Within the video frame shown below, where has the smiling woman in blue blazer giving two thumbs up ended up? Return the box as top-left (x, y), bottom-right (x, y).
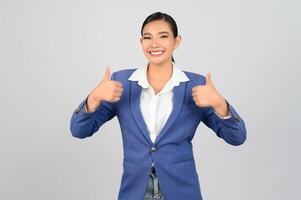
top-left (70, 12), bottom-right (246, 200)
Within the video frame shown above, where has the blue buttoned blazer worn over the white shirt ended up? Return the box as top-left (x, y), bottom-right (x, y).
top-left (70, 69), bottom-right (246, 200)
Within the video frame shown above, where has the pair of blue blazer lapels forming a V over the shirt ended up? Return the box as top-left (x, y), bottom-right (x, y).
top-left (130, 81), bottom-right (186, 145)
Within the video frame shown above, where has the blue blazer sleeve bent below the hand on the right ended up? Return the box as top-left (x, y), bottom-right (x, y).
top-left (202, 100), bottom-right (247, 146)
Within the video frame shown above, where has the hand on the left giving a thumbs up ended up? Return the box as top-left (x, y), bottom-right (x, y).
top-left (87, 66), bottom-right (123, 111)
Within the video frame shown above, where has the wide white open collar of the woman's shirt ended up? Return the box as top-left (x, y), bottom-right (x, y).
top-left (128, 62), bottom-right (190, 93)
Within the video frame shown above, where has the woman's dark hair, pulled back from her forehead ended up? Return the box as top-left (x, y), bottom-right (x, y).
top-left (141, 12), bottom-right (178, 63)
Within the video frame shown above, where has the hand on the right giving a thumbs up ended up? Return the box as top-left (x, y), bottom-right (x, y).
top-left (192, 73), bottom-right (226, 110)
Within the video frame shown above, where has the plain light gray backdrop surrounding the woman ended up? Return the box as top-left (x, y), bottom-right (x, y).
top-left (0, 0), bottom-right (301, 200)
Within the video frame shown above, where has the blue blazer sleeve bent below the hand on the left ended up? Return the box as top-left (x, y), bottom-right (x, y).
top-left (70, 72), bottom-right (116, 139)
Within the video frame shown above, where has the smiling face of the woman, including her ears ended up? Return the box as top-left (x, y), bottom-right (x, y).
top-left (140, 20), bottom-right (181, 64)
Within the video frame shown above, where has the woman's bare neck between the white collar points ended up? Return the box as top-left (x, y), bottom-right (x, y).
top-left (147, 62), bottom-right (173, 81)
